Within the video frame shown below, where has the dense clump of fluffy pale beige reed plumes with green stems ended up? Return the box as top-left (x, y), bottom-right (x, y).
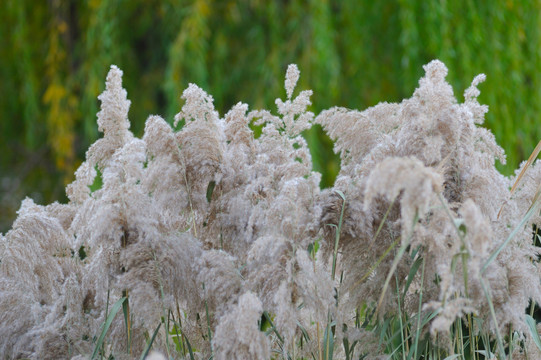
top-left (0, 60), bottom-right (541, 360)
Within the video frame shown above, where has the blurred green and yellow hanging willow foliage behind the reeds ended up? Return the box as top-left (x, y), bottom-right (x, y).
top-left (0, 0), bottom-right (541, 231)
